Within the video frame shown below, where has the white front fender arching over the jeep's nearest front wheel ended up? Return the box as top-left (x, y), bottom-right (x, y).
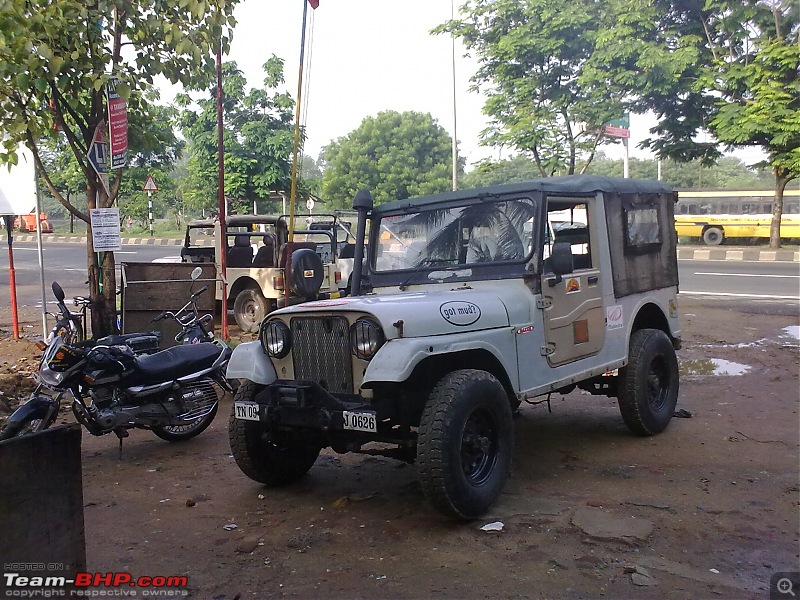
top-left (361, 327), bottom-right (519, 390)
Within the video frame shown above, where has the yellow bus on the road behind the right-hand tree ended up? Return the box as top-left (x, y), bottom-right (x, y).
top-left (675, 189), bottom-right (800, 246)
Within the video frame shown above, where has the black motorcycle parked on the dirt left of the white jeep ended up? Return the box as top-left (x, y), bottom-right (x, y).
top-left (0, 282), bottom-right (233, 442)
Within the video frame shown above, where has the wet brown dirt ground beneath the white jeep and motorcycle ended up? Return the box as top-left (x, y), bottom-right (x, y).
top-left (0, 299), bottom-right (800, 600)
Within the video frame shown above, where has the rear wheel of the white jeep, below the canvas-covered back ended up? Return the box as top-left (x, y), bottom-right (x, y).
top-left (617, 329), bottom-right (679, 436)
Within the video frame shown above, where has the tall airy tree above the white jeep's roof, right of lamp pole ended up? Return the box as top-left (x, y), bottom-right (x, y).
top-left (434, 0), bottom-right (629, 177)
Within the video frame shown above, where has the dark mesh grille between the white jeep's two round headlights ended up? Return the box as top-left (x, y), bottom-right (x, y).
top-left (290, 317), bottom-right (353, 394)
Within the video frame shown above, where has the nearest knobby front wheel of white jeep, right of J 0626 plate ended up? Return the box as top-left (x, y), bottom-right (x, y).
top-left (417, 369), bottom-right (514, 519)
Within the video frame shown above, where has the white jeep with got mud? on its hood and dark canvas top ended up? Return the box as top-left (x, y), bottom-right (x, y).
top-left (228, 176), bottom-right (680, 519)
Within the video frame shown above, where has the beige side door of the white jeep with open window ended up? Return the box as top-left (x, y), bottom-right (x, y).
top-left (539, 197), bottom-right (606, 367)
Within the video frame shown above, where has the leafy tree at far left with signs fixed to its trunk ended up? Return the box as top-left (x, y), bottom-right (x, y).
top-left (0, 0), bottom-right (238, 335)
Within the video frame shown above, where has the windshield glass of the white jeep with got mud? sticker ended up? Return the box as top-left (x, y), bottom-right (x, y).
top-left (370, 197), bottom-right (539, 283)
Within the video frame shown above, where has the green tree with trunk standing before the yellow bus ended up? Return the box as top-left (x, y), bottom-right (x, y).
top-left (591, 0), bottom-right (800, 247)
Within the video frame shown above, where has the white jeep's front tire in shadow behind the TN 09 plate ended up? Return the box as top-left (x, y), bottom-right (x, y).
top-left (228, 381), bottom-right (320, 487)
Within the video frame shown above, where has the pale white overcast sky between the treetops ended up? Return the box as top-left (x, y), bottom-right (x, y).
top-left (220, 0), bottom-right (761, 170)
